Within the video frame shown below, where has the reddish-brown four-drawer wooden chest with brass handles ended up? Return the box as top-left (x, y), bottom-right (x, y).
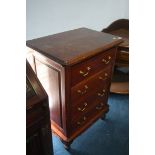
top-left (27, 28), bottom-right (122, 148)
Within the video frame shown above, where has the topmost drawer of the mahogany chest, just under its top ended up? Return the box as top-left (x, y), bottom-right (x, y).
top-left (71, 48), bottom-right (116, 86)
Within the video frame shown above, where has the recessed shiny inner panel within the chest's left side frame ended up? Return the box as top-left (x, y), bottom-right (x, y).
top-left (36, 59), bottom-right (62, 124)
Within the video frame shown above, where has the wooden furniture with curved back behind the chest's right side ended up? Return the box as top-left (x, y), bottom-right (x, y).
top-left (102, 19), bottom-right (129, 94)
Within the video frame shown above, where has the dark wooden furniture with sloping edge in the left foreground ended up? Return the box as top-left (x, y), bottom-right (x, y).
top-left (26, 62), bottom-right (53, 155)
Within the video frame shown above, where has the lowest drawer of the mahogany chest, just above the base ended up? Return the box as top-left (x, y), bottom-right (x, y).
top-left (71, 102), bottom-right (109, 132)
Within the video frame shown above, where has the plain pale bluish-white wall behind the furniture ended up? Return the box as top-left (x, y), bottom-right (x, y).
top-left (26, 0), bottom-right (129, 40)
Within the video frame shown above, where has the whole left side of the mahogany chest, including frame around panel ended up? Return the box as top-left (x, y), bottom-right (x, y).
top-left (30, 51), bottom-right (66, 133)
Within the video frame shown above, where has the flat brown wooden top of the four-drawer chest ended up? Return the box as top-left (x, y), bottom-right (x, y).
top-left (26, 28), bottom-right (122, 65)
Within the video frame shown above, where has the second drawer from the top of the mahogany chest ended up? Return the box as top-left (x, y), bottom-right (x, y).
top-left (71, 67), bottom-right (112, 105)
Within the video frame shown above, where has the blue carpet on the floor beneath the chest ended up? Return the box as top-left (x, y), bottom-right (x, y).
top-left (53, 94), bottom-right (129, 155)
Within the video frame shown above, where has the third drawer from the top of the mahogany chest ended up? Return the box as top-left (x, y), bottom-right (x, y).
top-left (71, 89), bottom-right (108, 121)
